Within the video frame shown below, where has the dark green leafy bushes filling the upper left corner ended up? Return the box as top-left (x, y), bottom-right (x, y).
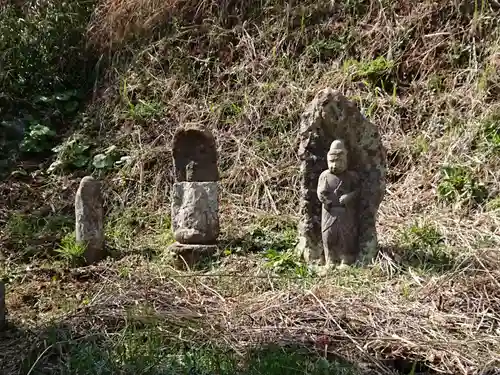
top-left (0, 0), bottom-right (93, 170)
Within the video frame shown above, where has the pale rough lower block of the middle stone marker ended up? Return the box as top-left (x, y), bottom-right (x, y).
top-left (172, 182), bottom-right (219, 245)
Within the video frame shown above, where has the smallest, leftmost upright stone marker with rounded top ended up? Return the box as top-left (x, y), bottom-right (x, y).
top-left (75, 176), bottom-right (104, 264)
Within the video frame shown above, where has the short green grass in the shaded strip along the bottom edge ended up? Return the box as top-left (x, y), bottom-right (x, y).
top-left (23, 325), bottom-right (359, 375)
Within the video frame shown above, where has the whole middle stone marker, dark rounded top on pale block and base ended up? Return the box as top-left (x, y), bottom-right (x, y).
top-left (169, 128), bottom-right (219, 267)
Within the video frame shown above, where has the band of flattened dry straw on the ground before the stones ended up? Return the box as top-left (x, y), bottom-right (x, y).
top-left (2, 250), bottom-right (500, 374)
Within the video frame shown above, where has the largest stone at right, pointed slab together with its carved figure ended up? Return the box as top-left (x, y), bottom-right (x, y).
top-left (298, 89), bottom-right (386, 264)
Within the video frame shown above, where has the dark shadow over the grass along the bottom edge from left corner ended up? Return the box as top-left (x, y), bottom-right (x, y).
top-left (0, 324), bottom-right (366, 375)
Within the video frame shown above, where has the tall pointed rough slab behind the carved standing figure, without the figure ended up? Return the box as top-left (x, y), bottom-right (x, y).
top-left (298, 89), bottom-right (386, 263)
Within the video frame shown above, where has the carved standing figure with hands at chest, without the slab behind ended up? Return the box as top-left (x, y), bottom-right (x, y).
top-left (317, 140), bottom-right (359, 264)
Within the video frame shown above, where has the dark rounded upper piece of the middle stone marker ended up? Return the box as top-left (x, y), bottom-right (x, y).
top-left (172, 128), bottom-right (219, 182)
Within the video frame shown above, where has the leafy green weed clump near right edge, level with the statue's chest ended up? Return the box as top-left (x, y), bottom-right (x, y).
top-left (437, 166), bottom-right (488, 205)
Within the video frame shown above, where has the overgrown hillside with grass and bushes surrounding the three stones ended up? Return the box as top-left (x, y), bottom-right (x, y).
top-left (0, 0), bottom-right (500, 374)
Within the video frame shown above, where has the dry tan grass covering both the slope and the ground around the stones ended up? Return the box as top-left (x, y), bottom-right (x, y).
top-left (0, 0), bottom-right (500, 374)
